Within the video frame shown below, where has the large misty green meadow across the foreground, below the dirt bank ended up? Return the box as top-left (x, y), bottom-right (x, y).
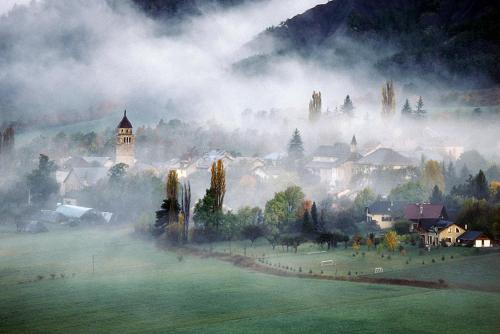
top-left (0, 228), bottom-right (500, 333)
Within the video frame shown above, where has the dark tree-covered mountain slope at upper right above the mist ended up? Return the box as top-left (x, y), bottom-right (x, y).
top-left (245, 0), bottom-right (500, 83)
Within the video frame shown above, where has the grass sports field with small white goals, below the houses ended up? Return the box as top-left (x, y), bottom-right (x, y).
top-left (192, 240), bottom-right (500, 292)
